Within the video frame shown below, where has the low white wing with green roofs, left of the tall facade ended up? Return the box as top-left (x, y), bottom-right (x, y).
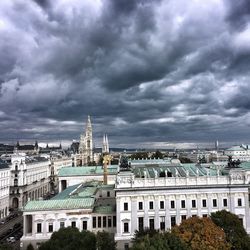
top-left (21, 182), bottom-right (116, 249)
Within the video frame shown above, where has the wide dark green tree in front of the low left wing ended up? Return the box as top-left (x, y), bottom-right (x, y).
top-left (39, 227), bottom-right (96, 250)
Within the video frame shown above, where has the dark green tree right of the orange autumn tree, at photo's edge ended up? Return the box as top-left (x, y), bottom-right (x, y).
top-left (211, 210), bottom-right (250, 250)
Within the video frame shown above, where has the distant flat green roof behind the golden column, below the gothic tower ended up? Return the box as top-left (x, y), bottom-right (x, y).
top-left (58, 165), bottom-right (118, 176)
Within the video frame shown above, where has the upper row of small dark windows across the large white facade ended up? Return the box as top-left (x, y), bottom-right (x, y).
top-left (123, 198), bottom-right (243, 211)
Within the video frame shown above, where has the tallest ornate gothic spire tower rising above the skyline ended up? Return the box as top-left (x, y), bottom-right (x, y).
top-left (79, 116), bottom-right (94, 165)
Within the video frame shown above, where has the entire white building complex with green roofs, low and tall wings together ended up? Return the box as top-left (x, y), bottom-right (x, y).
top-left (21, 158), bottom-right (250, 250)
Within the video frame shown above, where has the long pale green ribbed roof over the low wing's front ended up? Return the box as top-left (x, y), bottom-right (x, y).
top-left (24, 198), bottom-right (95, 211)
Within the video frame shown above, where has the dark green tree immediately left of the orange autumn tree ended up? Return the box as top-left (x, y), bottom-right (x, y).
top-left (132, 229), bottom-right (188, 250)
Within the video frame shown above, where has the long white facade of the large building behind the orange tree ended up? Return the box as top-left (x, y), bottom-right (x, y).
top-left (115, 164), bottom-right (250, 249)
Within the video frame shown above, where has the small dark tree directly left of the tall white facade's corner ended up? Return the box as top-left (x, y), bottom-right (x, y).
top-left (96, 231), bottom-right (116, 250)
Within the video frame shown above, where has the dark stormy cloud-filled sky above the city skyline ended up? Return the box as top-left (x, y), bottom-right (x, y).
top-left (0, 0), bottom-right (250, 147)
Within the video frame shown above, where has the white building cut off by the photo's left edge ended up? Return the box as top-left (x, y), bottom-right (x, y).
top-left (0, 159), bottom-right (10, 219)
